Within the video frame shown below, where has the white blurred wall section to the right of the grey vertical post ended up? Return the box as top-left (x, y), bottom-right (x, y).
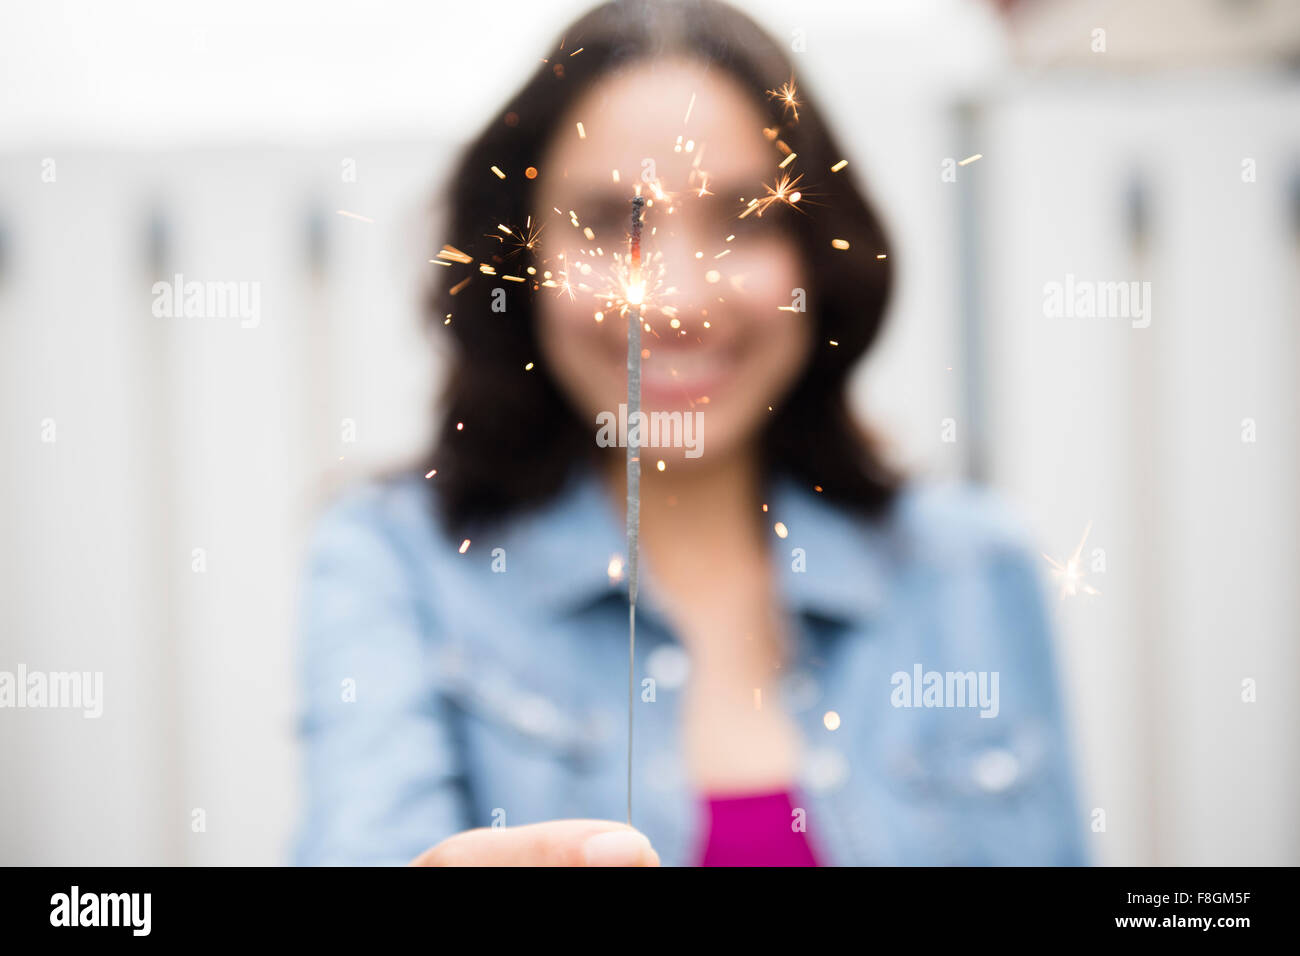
top-left (982, 73), bottom-right (1300, 865)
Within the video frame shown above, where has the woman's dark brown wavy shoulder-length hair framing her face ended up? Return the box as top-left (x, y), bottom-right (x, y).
top-left (426, 0), bottom-right (897, 533)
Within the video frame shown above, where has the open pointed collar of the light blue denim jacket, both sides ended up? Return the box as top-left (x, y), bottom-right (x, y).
top-left (491, 468), bottom-right (889, 623)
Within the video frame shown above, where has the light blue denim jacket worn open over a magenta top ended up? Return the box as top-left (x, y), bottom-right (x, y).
top-left (293, 472), bottom-right (1087, 865)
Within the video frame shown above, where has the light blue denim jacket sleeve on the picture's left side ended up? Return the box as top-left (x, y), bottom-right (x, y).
top-left (293, 489), bottom-right (468, 865)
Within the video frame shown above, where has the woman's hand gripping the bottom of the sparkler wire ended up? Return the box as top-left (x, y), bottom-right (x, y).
top-left (408, 819), bottom-right (659, 866)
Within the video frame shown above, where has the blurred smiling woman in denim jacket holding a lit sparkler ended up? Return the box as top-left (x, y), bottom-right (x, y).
top-left (298, 0), bottom-right (1082, 865)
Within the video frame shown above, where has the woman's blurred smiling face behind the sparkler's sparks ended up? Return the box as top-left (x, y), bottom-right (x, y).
top-left (533, 61), bottom-right (813, 462)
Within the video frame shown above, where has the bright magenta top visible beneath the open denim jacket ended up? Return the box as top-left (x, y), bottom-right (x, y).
top-left (699, 791), bottom-right (818, 866)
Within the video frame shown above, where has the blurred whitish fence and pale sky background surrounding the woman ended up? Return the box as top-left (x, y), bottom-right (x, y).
top-left (0, 0), bottom-right (1300, 865)
